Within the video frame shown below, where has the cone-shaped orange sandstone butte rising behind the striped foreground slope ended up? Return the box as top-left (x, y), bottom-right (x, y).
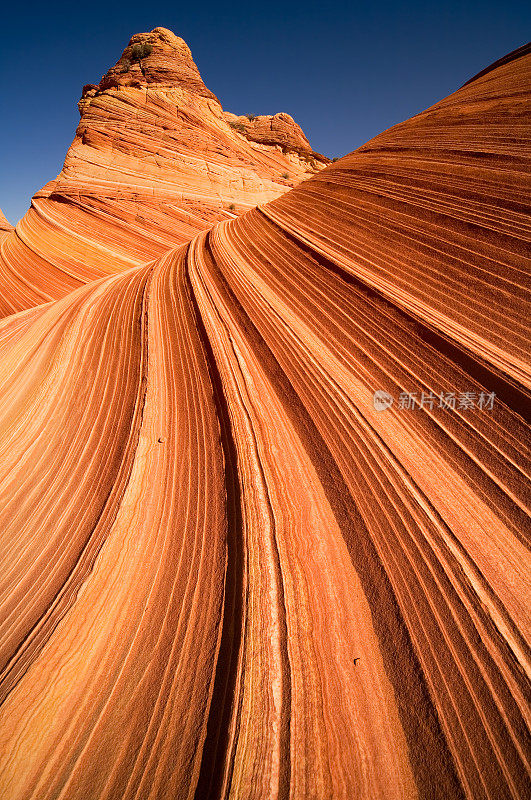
top-left (0, 28), bottom-right (328, 316)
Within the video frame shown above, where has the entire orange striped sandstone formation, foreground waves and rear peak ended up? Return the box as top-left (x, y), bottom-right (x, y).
top-left (0, 29), bottom-right (531, 800)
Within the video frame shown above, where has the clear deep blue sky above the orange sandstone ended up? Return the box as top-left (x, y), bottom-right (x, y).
top-left (0, 0), bottom-right (531, 223)
